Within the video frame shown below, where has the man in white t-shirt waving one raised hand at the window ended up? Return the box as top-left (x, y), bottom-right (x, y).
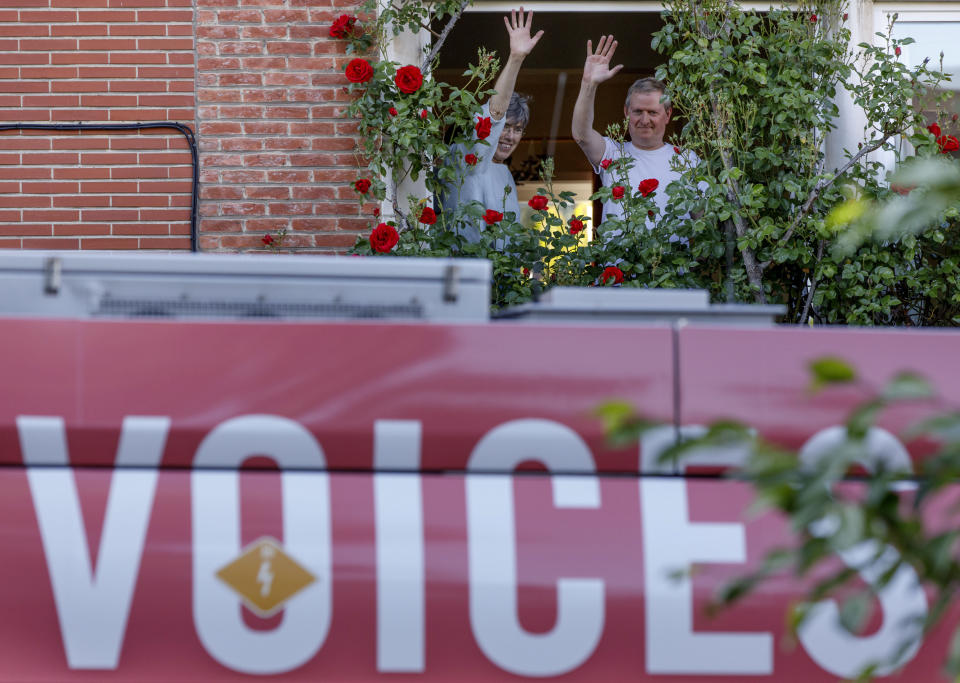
top-left (573, 36), bottom-right (696, 227)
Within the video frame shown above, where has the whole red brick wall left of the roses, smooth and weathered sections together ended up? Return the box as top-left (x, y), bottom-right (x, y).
top-left (0, 0), bottom-right (373, 251)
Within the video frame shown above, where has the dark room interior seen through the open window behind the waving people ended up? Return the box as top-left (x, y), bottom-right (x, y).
top-left (436, 2), bottom-right (673, 237)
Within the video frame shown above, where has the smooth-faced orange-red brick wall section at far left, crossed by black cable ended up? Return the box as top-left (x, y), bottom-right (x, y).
top-left (0, 0), bottom-right (195, 249)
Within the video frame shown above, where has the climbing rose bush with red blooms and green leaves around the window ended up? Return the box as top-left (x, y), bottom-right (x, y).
top-left (332, 0), bottom-right (960, 324)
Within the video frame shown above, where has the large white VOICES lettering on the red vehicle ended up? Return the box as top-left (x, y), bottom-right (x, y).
top-left (17, 415), bottom-right (927, 677)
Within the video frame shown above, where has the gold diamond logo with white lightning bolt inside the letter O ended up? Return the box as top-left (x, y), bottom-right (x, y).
top-left (217, 536), bottom-right (317, 617)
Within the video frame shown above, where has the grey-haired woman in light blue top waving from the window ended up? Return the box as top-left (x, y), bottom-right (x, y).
top-left (442, 7), bottom-right (543, 243)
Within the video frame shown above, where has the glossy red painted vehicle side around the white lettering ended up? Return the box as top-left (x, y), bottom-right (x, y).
top-left (0, 320), bottom-right (956, 683)
